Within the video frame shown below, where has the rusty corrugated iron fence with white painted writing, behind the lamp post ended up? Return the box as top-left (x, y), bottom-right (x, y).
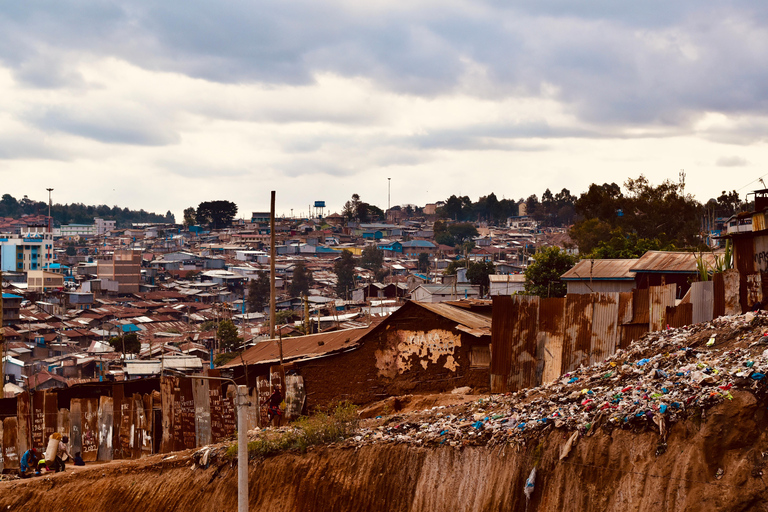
top-left (0, 366), bottom-right (305, 471)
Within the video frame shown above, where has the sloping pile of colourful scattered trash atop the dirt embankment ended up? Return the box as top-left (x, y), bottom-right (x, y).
top-left (346, 312), bottom-right (768, 452)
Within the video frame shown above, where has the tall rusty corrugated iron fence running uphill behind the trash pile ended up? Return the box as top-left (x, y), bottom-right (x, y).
top-left (491, 280), bottom-right (736, 393)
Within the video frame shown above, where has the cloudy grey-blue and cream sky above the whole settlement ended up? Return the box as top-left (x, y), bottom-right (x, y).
top-left (0, 0), bottom-right (768, 220)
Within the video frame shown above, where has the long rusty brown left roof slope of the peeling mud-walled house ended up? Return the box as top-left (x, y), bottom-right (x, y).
top-left (222, 321), bottom-right (378, 368)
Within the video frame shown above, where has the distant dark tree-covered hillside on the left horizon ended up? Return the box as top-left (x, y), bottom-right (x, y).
top-left (0, 194), bottom-right (176, 227)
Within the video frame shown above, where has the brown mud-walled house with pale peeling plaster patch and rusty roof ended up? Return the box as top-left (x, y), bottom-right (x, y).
top-left (223, 301), bottom-right (491, 409)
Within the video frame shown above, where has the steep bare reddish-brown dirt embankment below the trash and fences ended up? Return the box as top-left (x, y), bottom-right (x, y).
top-left (0, 392), bottom-right (768, 512)
